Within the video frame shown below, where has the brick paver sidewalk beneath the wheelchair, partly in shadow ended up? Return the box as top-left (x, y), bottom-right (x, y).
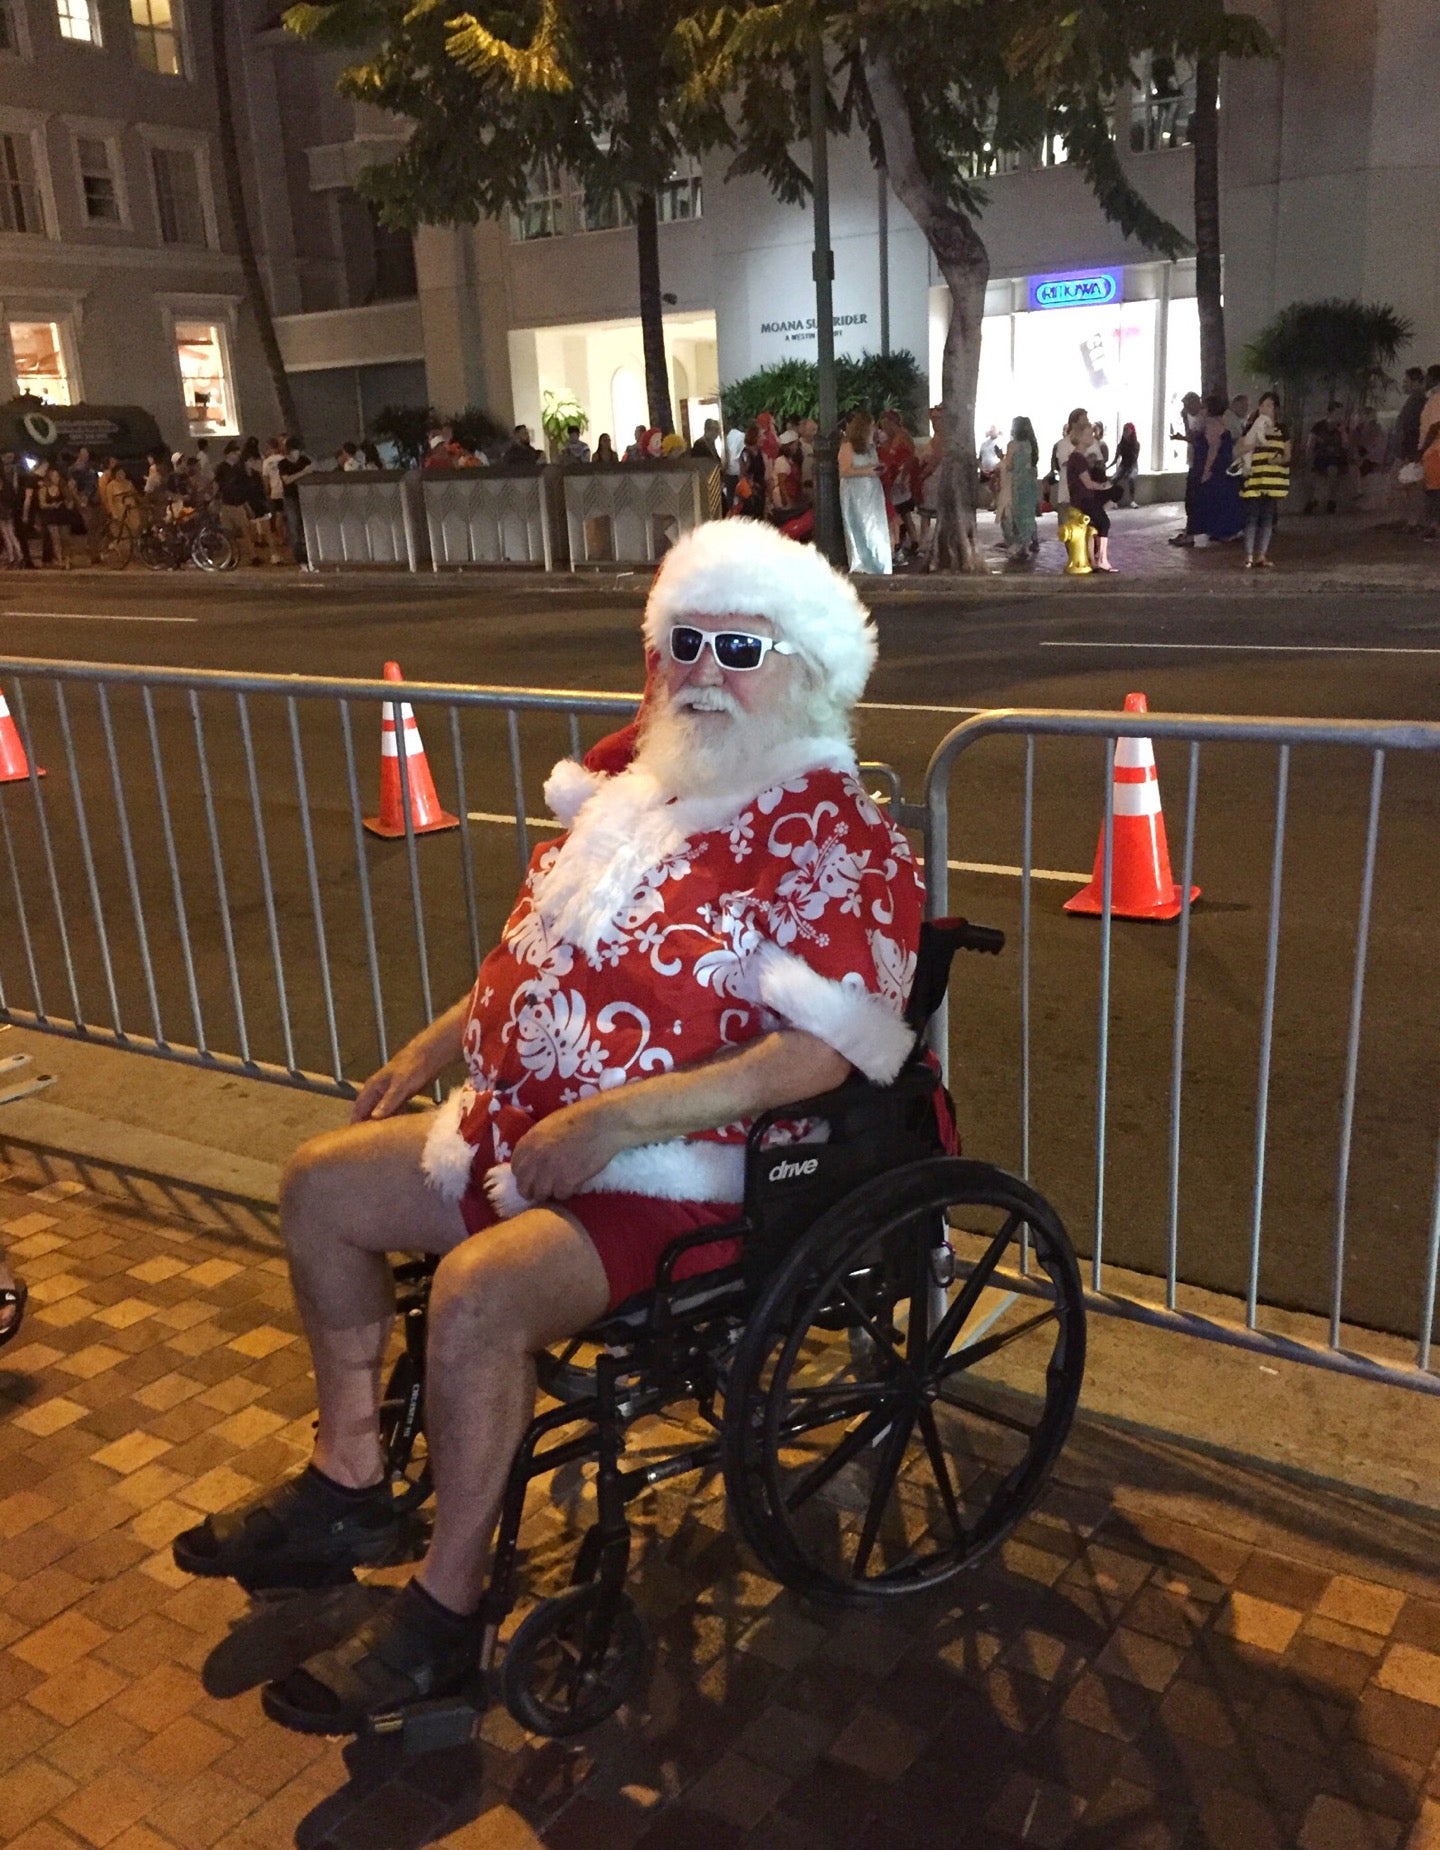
top-left (0, 1175), bottom-right (1440, 1850)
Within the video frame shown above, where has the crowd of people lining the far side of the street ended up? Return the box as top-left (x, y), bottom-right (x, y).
top-left (0, 366), bottom-right (1440, 574)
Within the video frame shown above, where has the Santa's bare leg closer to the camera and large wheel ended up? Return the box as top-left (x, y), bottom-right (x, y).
top-left (418, 1208), bottom-right (609, 1613)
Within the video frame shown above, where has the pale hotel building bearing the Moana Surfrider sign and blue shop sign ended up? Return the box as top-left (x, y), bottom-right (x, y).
top-left (294, 0), bottom-right (1440, 470)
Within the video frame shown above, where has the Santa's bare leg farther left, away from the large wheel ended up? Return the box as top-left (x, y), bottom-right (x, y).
top-left (279, 1112), bottom-right (465, 1487)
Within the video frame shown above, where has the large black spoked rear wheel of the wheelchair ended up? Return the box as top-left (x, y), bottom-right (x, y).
top-left (724, 1156), bottom-right (1085, 1604)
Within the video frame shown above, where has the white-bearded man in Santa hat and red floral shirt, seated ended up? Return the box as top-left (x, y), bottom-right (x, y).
top-left (174, 522), bottom-right (922, 1733)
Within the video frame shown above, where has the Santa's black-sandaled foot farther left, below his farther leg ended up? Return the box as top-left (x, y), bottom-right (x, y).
top-left (172, 1465), bottom-right (400, 1589)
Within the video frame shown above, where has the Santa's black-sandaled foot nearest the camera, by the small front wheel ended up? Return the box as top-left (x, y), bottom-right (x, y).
top-left (261, 1580), bottom-right (481, 1735)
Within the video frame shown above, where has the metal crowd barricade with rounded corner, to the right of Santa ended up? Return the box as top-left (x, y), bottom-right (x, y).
top-left (921, 709), bottom-right (1440, 1393)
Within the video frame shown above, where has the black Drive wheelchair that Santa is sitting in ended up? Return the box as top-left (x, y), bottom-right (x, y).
top-left (370, 919), bottom-right (1085, 1752)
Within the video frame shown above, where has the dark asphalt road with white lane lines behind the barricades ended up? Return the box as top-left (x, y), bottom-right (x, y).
top-left (0, 572), bottom-right (1440, 1332)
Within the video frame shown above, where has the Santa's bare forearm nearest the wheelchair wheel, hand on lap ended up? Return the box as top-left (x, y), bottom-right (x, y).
top-left (511, 1029), bottom-right (850, 1201)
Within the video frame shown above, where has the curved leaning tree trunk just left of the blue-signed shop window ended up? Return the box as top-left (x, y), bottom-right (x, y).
top-left (864, 54), bottom-right (990, 572)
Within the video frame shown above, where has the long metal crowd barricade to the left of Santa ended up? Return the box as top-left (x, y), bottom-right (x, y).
top-left (0, 657), bottom-right (639, 1097)
